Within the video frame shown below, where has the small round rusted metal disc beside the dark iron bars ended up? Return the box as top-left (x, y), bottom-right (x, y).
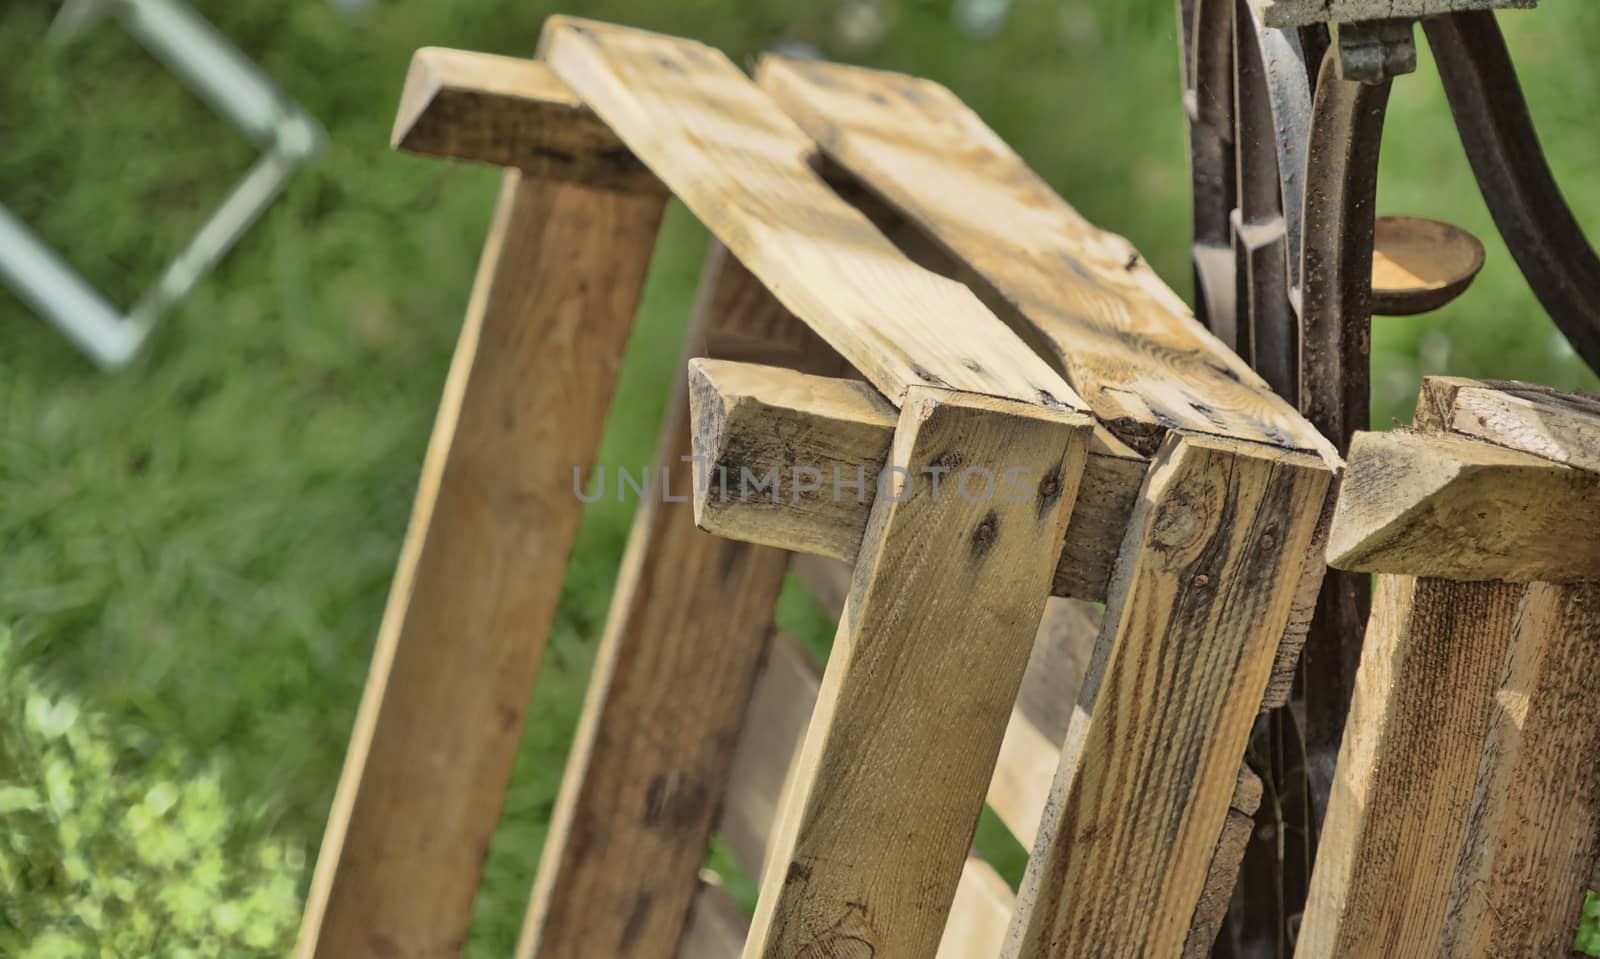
top-left (1373, 216), bottom-right (1483, 317)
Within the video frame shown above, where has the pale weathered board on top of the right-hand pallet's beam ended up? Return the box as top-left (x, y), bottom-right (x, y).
top-left (1418, 376), bottom-right (1600, 472)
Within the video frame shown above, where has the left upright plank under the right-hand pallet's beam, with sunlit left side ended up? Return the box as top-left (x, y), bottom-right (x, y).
top-left (1294, 576), bottom-right (1523, 959)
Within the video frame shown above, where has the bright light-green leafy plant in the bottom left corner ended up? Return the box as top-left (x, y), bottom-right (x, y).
top-left (0, 631), bottom-right (306, 959)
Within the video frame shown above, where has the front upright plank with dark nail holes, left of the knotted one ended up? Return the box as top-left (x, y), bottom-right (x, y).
top-left (744, 387), bottom-right (1090, 957)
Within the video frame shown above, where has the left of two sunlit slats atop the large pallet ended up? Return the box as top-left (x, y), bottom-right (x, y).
top-left (541, 18), bottom-right (1083, 410)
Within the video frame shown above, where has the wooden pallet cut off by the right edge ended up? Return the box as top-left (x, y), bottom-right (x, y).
top-left (1296, 378), bottom-right (1600, 959)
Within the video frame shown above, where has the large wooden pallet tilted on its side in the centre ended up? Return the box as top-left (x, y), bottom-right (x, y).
top-left (299, 18), bottom-right (1339, 959)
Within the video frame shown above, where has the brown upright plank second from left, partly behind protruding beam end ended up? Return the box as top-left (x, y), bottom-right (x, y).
top-left (517, 243), bottom-right (789, 959)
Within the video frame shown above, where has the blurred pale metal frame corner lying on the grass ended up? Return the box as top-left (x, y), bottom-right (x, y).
top-left (0, 0), bottom-right (326, 370)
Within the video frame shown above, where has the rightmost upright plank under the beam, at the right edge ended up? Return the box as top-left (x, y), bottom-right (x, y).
top-left (1440, 583), bottom-right (1600, 959)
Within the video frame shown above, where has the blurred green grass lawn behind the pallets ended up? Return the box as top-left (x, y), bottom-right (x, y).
top-left (0, 0), bottom-right (1600, 956)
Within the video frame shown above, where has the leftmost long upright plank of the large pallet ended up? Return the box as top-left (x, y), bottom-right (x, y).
top-left (299, 171), bottom-right (664, 959)
